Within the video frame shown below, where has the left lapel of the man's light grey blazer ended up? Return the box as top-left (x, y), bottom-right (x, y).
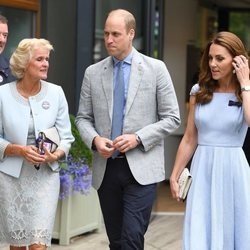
top-left (102, 57), bottom-right (113, 120)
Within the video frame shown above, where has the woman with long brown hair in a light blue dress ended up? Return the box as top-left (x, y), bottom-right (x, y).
top-left (170, 32), bottom-right (250, 250)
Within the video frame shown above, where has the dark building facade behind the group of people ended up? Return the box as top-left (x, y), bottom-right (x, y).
top-left (0, 0), bottom-right (250, 178)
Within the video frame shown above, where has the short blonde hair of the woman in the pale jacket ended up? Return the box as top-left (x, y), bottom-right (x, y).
top-left (10, 38), bottom-right (53, 80)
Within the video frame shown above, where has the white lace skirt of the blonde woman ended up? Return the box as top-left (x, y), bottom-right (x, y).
top-left (0, 163), bottom-right (60, 246)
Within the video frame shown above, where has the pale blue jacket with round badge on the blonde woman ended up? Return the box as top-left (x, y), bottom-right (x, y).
top-left (0, 81), bottom-right (74, 177)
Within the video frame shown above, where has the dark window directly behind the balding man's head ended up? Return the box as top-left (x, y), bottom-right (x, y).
top-left (94, 0), bottom-right (164, 62)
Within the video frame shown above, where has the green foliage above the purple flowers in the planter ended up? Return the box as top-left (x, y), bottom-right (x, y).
top-left (69, 114), bottom-right (92, 166)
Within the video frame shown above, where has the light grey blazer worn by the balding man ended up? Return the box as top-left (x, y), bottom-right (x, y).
top-left (76, 48), bottom-right (180, 189)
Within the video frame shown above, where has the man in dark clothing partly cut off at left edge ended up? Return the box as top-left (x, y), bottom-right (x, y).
top-left (0, 15), bottom-right (15, 85)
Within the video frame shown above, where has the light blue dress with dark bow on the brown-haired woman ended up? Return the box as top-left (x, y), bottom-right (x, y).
top-left (183, 85), bottom-right (250, 250)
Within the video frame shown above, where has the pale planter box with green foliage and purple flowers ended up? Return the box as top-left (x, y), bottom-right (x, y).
top-left (53, 115), bottom-right (101, 245)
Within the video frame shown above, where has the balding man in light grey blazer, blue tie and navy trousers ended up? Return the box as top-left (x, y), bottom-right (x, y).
top-left (76, 9), bottom-right (180, 250)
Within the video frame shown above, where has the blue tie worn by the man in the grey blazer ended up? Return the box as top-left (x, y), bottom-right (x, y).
top-left (111, 61), bottom-right (125, 158)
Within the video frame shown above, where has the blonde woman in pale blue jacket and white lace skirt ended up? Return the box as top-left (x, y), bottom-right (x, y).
top-left (0, 38), bottom-right (74, 250)
